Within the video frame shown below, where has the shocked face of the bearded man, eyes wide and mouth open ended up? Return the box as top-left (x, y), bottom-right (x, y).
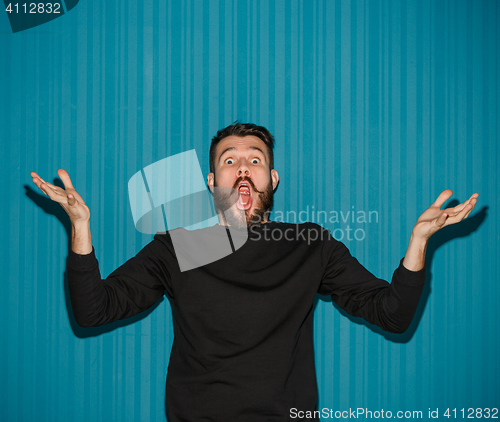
top-left (207, 136), bottom-right (279, 227)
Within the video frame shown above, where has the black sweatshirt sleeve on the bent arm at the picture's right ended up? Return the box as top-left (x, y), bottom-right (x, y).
top-left (319, 236), bottom-right (425, 333)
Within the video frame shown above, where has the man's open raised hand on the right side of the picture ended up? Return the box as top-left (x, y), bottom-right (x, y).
top-left (413, 189), bottom-right (479, 240)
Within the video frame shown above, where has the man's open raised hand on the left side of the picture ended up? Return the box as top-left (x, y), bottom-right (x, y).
top-left (30, 169), bottom-right (90, 225)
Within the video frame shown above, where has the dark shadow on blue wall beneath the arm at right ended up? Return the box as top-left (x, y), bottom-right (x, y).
top-left (314, 200), bottom-right (488, 343)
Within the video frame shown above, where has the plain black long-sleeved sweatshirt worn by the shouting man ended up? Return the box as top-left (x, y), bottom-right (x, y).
top-left (68, 221), bottom-right (425, 422)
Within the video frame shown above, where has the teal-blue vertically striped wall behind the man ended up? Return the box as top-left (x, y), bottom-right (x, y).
top-left (0, 0), bottom-right (500, 422)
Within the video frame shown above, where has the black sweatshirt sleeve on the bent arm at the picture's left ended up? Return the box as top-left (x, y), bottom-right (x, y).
top-left (67, 235), bottom-right (172, 327)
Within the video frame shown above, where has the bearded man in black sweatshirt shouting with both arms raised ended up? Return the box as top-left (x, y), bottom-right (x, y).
top-left (32, 124), bottom-right (478, 422)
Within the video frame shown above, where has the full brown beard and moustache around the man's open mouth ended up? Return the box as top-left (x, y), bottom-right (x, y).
top-left (214, 177), bottom-right (274, 229)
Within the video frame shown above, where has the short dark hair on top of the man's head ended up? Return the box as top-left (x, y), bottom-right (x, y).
top-left (209, 121), bottom-right (274, 174)
